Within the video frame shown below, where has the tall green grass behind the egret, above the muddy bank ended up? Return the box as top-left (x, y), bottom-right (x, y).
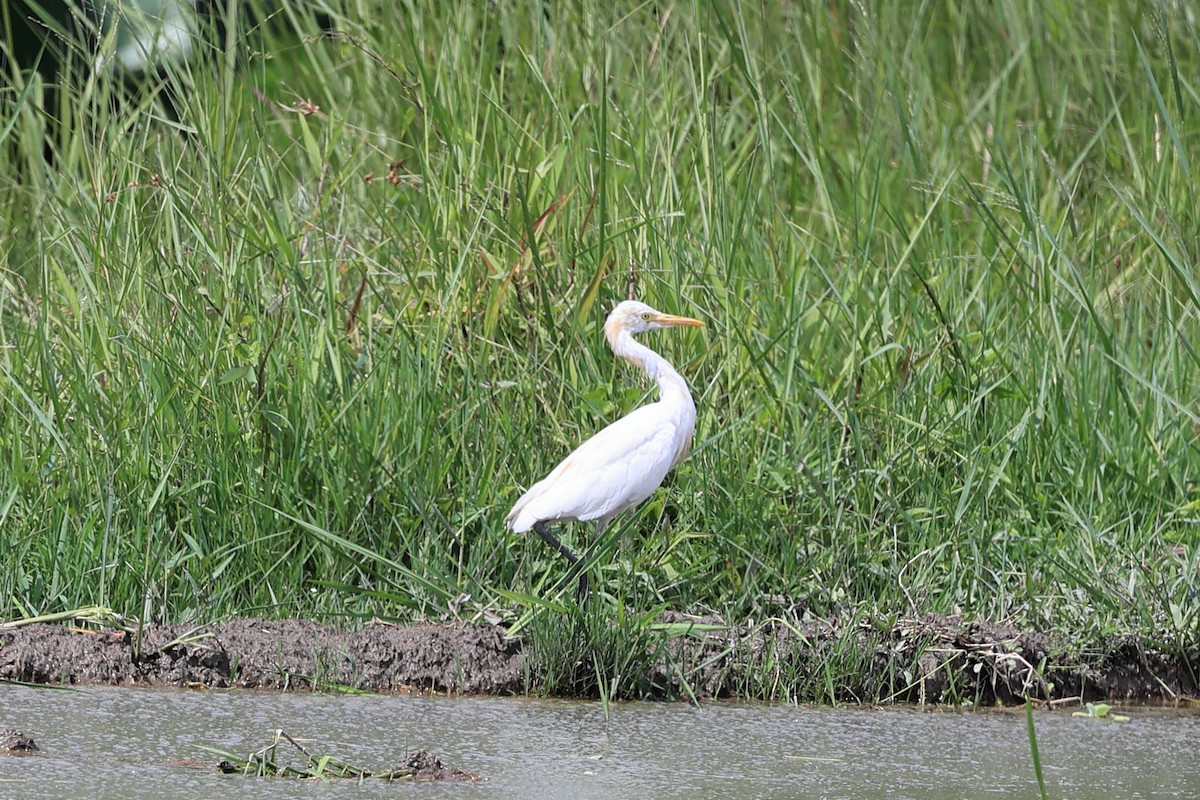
top-left (0, 0), bottom-right (1200, 685)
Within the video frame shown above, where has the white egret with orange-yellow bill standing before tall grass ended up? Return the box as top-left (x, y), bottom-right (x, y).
top-left (505, 300), bottom-right (704, 596)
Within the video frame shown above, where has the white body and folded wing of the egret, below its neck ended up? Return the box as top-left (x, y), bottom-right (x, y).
top-left (506, 403), bottom-right (691, 533)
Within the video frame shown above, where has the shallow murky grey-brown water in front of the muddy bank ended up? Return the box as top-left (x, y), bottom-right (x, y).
top-left (0, 685), bottom-right (1200, 800)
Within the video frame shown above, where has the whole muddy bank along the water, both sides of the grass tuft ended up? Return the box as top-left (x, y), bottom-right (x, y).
top-left (0, 614), bottom-right (1200, 704)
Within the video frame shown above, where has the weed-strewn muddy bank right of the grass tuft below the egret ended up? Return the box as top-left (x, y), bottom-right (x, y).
top-left (657, 615), bottom-right (1200, 705)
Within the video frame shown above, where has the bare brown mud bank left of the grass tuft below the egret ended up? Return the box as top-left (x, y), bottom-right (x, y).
top-left (0, 619), bottom-right (523, 694)
